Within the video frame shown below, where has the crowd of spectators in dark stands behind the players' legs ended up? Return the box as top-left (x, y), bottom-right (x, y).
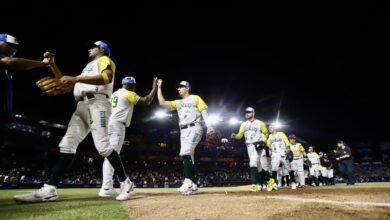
top-left (0, 153), bottom-right (390, 186)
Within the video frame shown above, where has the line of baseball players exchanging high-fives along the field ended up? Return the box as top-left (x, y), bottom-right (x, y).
top-left (0, 34), bottom-right (350, 205)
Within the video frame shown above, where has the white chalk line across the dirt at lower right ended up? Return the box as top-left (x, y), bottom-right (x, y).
top-left (259, 196), bottom-right (390, 207)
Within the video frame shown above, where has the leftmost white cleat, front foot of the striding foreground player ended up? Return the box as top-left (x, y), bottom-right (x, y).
top-left (14, 184), bottom-right (58, 202)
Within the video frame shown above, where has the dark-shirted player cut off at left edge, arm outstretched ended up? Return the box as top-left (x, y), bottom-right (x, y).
top-left (0, 34), bottom-right (50, 119)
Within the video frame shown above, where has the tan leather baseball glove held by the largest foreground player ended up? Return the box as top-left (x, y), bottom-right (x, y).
top-left (36, 76), bottom-right (73, 96)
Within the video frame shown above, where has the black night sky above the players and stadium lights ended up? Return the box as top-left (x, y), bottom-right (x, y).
top-left (1, 1), bottom-right (390, 146)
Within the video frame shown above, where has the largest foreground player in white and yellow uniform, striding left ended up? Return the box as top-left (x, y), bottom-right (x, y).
top-left (14, 41), bottom-right (134, 202)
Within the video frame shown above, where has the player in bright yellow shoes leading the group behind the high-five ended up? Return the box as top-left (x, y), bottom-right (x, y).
top-left (231, 107), bottom-right (269, 192)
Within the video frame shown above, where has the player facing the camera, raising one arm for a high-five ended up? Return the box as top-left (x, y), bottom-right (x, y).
top-left (157, 79), bottom-right (213, 195)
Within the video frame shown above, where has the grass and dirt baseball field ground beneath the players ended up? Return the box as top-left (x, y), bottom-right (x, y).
top-left (0, 183), bottom-right (390, 220)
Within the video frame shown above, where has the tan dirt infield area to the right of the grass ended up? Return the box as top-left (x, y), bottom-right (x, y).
top-left (124, 187), bottom-right (390, 220)
